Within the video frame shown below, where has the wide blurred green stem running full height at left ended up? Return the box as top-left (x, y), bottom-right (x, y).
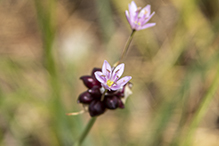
top-left (34, 0), bottom-right (72, 145)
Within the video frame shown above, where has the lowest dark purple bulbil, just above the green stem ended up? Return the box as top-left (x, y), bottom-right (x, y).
top-left (88, 100), bottom-right (106, 117)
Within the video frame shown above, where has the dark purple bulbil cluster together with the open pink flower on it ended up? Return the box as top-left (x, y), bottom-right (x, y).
top-left (78, 61), bottom-right (132, 117)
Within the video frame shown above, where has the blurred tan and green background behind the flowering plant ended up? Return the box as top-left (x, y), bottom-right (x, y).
top-left (0, 0), bottom-right (219, 146)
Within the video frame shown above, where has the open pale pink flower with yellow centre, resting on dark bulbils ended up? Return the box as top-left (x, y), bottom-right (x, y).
top-left (94, 60), bottom-right (132, 91)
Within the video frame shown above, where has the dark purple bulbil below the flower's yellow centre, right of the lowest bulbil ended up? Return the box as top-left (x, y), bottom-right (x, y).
top-left (103, 96), bottom-right (118, 109)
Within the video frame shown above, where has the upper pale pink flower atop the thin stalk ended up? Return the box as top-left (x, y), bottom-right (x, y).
top-left (125, 1), bottom-right (156, 30)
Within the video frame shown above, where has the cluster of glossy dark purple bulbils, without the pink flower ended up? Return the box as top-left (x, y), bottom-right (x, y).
top-left (78, 68), bottom-right (125, 117)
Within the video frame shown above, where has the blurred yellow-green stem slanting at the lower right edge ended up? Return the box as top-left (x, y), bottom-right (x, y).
top-left (182, 67), bottom-right (219, 146)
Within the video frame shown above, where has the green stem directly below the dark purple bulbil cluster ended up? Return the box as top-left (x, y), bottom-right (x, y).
top-left (74, 117), bottom-right (97, 146)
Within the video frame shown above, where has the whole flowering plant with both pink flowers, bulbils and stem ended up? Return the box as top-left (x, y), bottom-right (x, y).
top-left (68, 1), bottom-right (156, 146)
